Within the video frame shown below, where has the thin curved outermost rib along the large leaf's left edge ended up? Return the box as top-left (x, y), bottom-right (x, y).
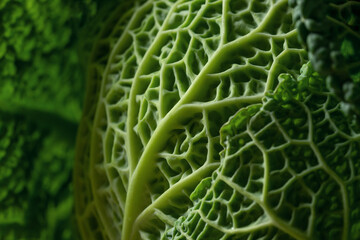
top-left (89, 0), bottom-right (155, 239)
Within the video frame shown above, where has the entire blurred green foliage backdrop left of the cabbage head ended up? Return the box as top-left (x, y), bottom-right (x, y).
top-left (0, 0), bottom-right (106, 240)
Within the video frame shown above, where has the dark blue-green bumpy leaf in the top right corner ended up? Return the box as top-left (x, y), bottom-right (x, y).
top-left (289, 0), bottom-right (360, 116)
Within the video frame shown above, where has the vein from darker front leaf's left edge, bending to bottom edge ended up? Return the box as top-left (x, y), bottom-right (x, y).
top-left (247, 124), bottom-right (310, 240)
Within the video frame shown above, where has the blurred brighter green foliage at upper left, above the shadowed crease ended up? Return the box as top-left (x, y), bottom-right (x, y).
top-left (0, 0), bottom-right (89, 121)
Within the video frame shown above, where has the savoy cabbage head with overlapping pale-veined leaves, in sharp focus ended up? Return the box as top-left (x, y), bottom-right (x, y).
top-left (74, 0), bottom-right (360, 240)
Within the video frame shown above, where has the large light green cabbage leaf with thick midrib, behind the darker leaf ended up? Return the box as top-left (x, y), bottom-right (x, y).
top-left (74, 0), bottom-right (312, 240)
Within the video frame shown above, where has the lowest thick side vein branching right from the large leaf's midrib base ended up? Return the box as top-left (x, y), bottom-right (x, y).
top-left (134, 163), bottom-right (220, 229)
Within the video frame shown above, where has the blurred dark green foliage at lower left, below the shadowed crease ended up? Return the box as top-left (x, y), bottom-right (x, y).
top-left (0, 112), bottom-right (76, 240)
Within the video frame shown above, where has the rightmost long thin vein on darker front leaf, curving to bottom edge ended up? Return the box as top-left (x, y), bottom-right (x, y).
top-left (303, 104), bottom-right (350, 240)
